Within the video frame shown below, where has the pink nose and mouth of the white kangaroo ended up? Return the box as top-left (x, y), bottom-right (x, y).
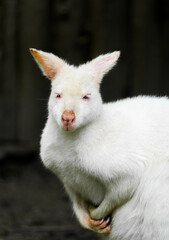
top-left (61, 110), bottom-right (75, 131)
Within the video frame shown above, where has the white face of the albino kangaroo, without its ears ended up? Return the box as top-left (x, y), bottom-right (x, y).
top-left (49, 68), bottom-right (102, 131)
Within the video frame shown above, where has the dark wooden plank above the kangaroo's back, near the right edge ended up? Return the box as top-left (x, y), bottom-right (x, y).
top-left (132, 0), bottom-right (161, 95)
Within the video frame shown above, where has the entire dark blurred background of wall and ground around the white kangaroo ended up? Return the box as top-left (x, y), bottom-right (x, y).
top-left (0, 0), bottom-right (169, 240)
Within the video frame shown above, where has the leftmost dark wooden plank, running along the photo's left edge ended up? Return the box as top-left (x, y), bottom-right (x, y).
top-left (0, 0), bottom-right (17, 140)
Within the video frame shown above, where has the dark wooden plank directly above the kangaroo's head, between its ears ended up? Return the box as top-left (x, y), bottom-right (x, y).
top-left (52, 0), bottom-right (90, 65)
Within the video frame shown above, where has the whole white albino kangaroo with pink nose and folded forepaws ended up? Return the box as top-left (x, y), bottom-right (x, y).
top-left (30, 49), bottom-right (169, 240)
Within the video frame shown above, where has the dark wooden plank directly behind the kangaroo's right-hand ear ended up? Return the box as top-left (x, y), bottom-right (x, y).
top-left (91, 0), bottom-right (130, 101)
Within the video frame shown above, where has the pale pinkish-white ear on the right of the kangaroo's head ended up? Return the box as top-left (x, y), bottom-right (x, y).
top-left (88, 51), bottom-right (120, 83)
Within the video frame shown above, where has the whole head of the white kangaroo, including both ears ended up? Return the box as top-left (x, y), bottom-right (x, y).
top-left (30, 48), bottom-right (120, 131)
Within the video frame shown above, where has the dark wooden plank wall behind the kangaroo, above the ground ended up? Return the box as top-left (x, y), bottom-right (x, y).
top-left (0, 0), bottom-right (169, 148)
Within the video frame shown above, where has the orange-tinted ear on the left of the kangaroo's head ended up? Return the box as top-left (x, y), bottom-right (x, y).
top-left (30, 48), bottom-right (66, 80)
